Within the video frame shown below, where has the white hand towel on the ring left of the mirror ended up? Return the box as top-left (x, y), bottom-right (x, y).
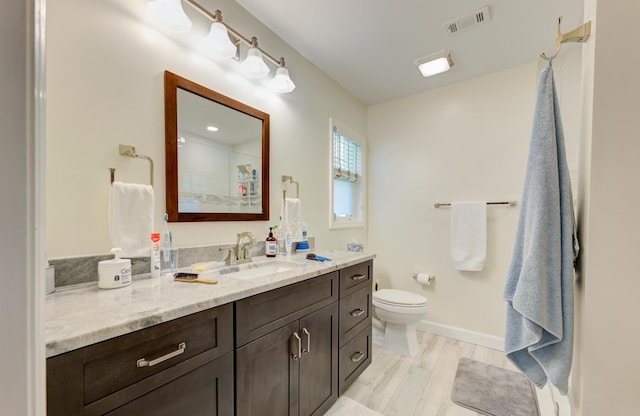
top-left (109, 182), bottom-right (154, 257)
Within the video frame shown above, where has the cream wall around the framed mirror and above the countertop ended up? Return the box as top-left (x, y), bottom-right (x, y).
top-left (47, 0), bottom-right (367, 257)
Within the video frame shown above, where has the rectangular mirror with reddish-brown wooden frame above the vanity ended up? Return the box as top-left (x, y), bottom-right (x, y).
top-left (165, 71), bottom-right (269, 222)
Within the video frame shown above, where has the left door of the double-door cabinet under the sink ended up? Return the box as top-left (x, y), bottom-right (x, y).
top-left (236, 321), bottom-right (301, 416)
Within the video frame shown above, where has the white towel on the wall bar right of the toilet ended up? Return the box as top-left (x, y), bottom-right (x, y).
top-left (451, 201), bottom-right (487, 272)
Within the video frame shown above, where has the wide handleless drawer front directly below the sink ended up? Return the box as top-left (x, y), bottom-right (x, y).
top-left (236, 271), bottom-right (338, 347)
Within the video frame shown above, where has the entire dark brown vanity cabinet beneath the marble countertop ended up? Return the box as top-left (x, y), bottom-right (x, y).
top-left (47, 261), bottom-right (373, 416)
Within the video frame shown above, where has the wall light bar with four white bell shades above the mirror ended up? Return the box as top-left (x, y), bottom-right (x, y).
top-left (147, 0), bottom-right (296, 93)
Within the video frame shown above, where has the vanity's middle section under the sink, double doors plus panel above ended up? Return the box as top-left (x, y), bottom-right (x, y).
top-left (236, 272), bottom-right (339, 416)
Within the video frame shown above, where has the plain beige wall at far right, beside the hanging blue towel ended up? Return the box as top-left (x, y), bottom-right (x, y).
top-left (572, 0), bottom-right (640, 416)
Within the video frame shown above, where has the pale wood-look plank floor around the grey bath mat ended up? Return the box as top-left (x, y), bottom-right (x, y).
top-left (344, 332), bottom-right (554, 416)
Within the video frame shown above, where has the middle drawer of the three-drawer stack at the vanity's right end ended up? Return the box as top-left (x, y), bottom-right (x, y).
top-left (340, 286), bottom-right (371, 346)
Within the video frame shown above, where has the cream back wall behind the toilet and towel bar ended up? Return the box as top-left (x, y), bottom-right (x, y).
top-left (368, 52), bottom-right (581, 337)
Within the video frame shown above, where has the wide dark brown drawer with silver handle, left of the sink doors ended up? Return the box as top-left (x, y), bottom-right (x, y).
top-left (83, 304), bottom-right (233, 405)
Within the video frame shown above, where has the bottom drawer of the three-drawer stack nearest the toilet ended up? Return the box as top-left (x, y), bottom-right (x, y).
top-left (338, 325), bottom-right (372, 394)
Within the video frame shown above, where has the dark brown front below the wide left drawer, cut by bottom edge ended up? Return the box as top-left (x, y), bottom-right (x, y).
top-left (106, 353), bottom-right (233, 416)
